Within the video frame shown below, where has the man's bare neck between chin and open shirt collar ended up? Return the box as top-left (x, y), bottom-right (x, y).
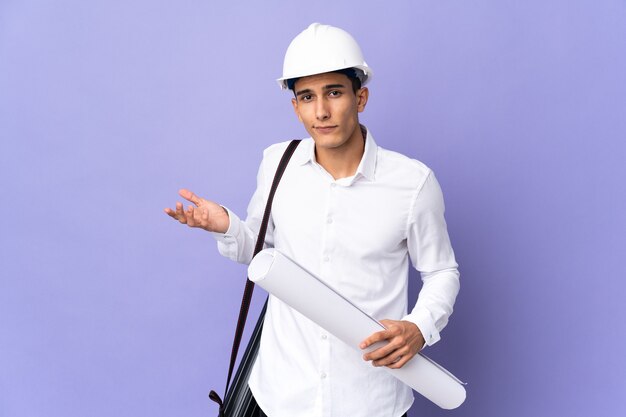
top-left (315, 126), bottom-right (367, 180)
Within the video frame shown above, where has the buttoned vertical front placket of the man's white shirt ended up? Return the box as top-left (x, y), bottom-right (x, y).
top-left (319, 182), bottom-right (339, 417)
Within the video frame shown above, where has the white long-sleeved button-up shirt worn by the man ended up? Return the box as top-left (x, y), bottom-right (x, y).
top-left (215, 127), bottom-right (459, 417)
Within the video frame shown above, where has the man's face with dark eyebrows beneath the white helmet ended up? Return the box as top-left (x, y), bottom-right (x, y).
top-left (291, 72), bottom-right (369, 150)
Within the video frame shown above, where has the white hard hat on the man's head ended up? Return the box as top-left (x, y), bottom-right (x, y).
top-left (276, 23), bottom-right (373, 90)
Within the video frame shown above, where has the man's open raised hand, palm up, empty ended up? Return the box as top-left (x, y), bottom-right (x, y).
top-left (165, 188), bottom-right (230, 233)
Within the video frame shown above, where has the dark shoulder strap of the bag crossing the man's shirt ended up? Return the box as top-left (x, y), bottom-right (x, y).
top-left (209, 140), bottom-right (300, 407)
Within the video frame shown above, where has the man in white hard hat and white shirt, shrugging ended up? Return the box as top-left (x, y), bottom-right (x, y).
top-left (165, 24), bottom-right (459, 417)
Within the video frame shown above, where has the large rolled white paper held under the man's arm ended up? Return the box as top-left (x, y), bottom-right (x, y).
top-left (248, 249), bottom-right (465, 410)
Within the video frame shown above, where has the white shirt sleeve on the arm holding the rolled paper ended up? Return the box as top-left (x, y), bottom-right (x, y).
top-left (404, 172), bottom-right (460, 346)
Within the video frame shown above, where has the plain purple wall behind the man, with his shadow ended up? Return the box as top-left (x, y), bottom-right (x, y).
top-left (0, 0), bottom-right (626, 417)
